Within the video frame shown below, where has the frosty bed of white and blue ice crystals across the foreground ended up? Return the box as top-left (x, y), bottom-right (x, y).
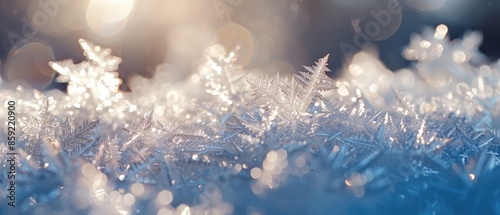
top-left (0, 25), bottom-right (500, 214)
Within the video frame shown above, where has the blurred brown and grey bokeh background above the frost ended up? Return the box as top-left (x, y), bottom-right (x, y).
top-left (0, 0), bottom-right (500, 91)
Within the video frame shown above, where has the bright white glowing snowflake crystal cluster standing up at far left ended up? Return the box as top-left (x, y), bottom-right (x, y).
top-left (49, 39), bottom-right (125, 124)
